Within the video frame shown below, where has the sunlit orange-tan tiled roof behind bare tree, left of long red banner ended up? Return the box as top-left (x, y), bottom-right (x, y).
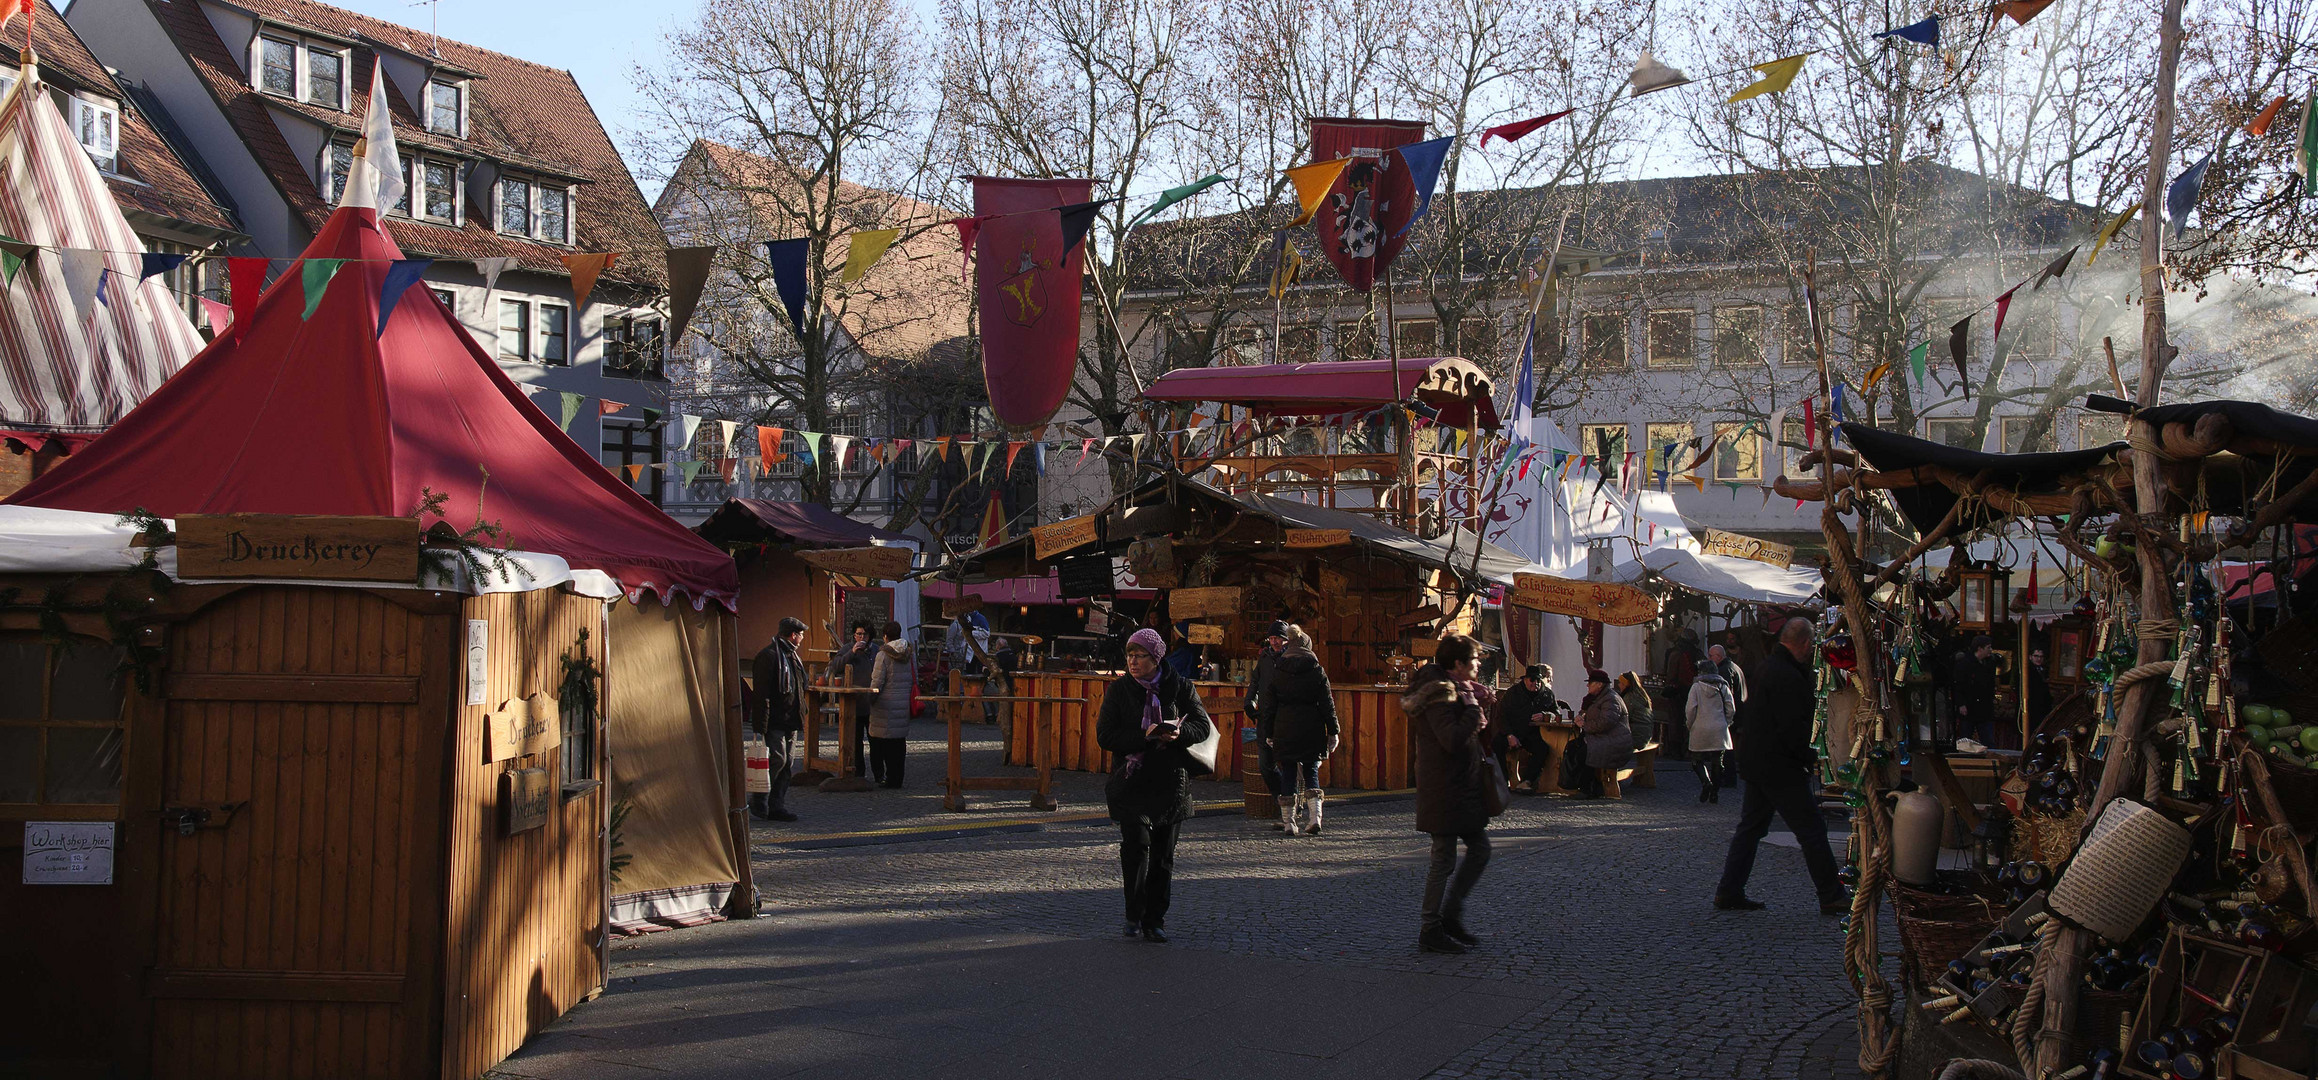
top-left (661, 139), bottom-right (974, 357)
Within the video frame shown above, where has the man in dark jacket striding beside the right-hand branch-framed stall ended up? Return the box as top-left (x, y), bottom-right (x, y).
top-left (1715, 616), bottom-right (1852, 915)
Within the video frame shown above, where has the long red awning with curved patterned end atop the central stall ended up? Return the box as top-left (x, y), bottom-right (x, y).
top-left (1143, 357), bottom-right (1497, 429)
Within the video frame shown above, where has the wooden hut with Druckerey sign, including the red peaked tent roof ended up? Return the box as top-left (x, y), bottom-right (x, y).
top-left (0, 209), bottom-right (751, 1080)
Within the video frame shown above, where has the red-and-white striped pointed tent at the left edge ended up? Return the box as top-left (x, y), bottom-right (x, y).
top-left (0, 63), bottom-right (202, 433)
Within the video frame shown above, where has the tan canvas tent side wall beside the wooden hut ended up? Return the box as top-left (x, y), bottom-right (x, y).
top-left (605, 603), bottom-right (742, 915)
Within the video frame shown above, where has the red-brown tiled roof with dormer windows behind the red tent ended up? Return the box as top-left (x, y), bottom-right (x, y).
top-left (146, 0), bottom-right (665, 287)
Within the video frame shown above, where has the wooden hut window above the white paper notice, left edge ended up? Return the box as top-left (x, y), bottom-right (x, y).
top-left (0, 633), bottom-right (127, 807)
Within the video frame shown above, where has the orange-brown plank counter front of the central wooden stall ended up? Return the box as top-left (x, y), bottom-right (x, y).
top-left (1006, 672), bottom-right (1416, 790)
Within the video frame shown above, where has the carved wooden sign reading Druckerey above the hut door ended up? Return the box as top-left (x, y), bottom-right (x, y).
top-left (176, 515), bottom-right (420, 582)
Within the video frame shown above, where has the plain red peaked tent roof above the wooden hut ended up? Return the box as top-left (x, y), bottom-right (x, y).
top-left (7, 206), bottom-right (739, 605)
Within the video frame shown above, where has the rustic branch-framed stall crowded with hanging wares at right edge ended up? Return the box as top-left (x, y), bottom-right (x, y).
top-left (1780, 396), bottom-right (2318, 1078)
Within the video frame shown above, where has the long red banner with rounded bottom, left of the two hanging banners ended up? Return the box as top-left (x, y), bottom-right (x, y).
top-left (974, 176), bottom-right (1094, 426)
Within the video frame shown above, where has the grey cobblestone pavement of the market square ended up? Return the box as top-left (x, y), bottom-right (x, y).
top-left (498, 728), bottom-right (1896, 1080)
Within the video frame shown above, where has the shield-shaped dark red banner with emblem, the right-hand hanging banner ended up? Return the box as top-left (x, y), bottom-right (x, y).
top-left (1312, 118), bottom-right (1426, 292)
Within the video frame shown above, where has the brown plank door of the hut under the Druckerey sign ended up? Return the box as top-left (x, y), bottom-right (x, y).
top-left (146, 586), bottom-right (454, 1080)
